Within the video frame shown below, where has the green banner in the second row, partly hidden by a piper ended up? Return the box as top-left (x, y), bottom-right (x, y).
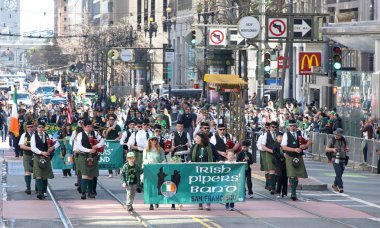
top-left (51, 140), bottom-right (124, 170)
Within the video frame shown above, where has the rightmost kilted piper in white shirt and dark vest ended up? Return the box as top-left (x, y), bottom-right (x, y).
top-left (281, 120), bottom-right (311, 201)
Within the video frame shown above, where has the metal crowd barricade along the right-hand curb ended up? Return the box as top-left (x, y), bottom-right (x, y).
top-left (309, 132), bottom-right (380, 172)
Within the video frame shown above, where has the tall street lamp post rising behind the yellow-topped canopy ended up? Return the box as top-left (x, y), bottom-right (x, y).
top-left (196, 0), bottom-right (215, 102)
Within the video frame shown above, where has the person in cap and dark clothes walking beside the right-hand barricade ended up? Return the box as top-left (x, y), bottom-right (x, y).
top-left (326, 128), bottom-right (348, 193)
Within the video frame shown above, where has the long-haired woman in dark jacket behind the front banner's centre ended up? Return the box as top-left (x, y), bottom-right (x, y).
top-left (188, 132), bottom-right (219, 211)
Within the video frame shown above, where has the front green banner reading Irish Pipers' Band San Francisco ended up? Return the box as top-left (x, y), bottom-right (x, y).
top-left (144, 163), bottom-right (245, 204)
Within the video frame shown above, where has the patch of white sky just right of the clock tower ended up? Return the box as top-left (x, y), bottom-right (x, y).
top-left (20, 0), bottom-right (54, 33)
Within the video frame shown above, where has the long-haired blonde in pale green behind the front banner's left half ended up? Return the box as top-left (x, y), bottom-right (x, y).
top-left (143, 135), bottom-right (165, 210)
